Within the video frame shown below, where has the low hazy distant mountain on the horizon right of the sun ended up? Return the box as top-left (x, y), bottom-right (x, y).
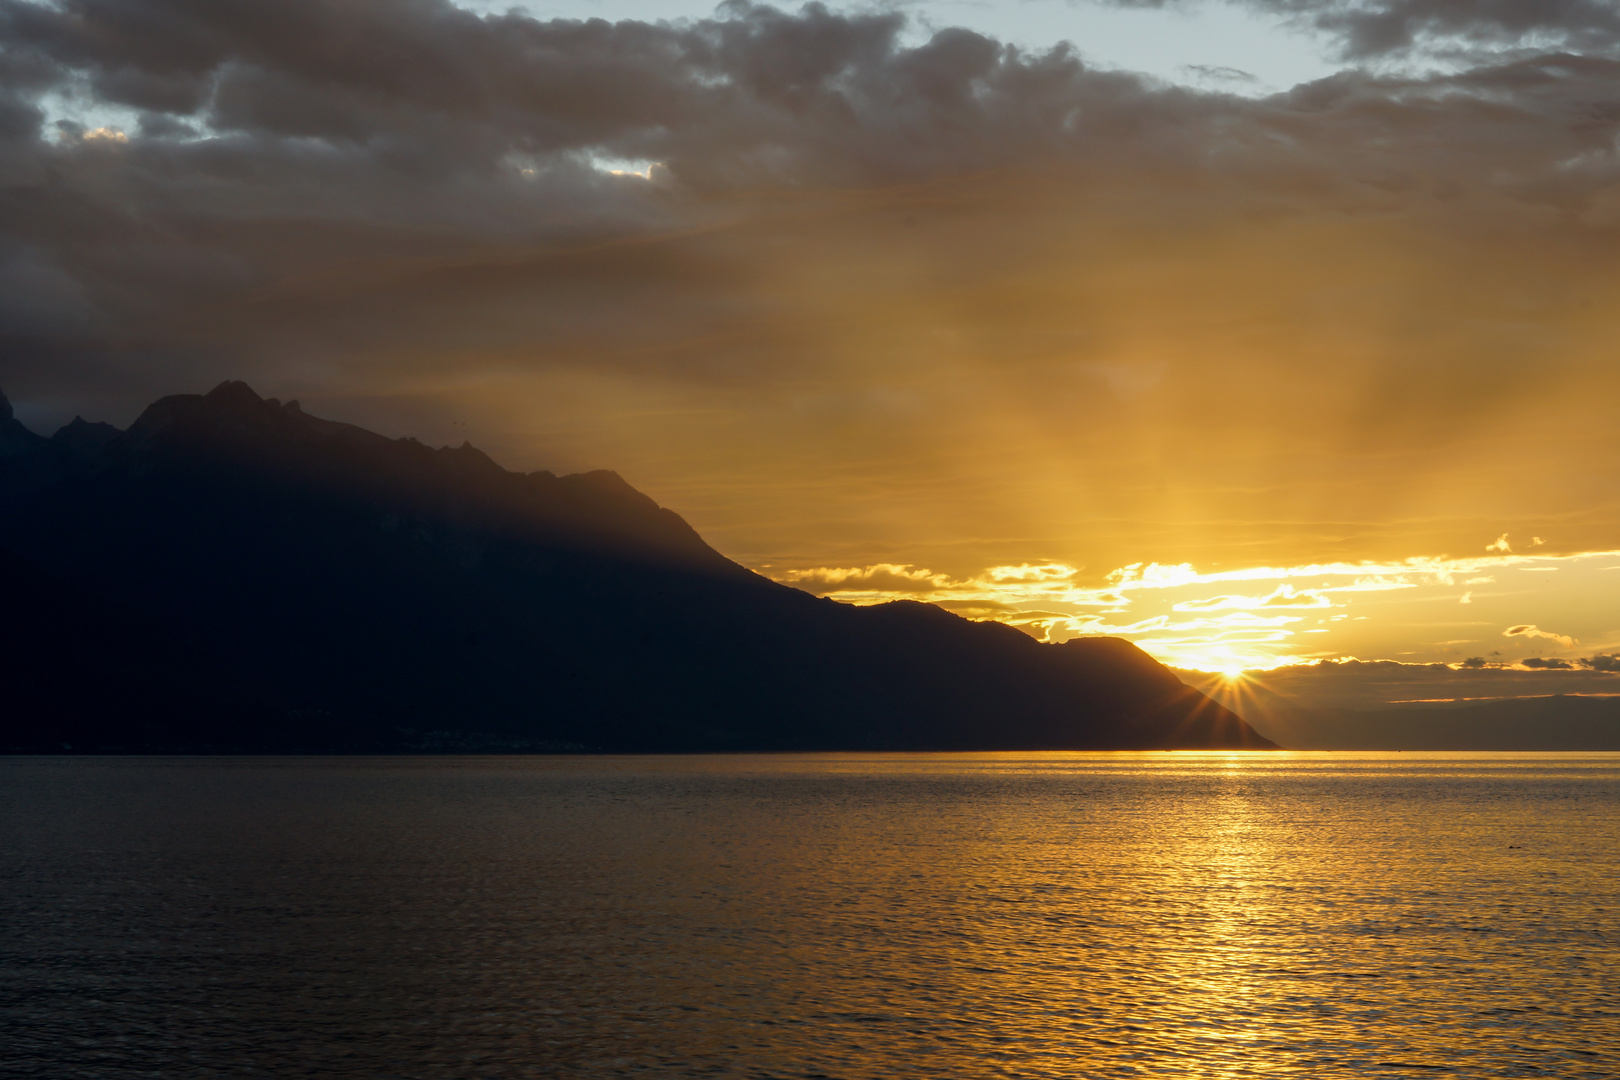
top-left (1257, 695), bottom-right (1620, 751)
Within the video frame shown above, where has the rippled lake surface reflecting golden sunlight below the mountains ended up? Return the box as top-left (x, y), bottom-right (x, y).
top-left (0, 753), bottom-right (1620, 1080)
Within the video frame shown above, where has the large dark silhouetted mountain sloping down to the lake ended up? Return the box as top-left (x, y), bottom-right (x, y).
top-left (0, 382), bottom-right (1272, 751)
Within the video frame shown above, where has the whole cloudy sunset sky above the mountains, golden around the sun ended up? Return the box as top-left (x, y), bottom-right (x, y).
top-left (0, 0), bottom-right (1620, 704)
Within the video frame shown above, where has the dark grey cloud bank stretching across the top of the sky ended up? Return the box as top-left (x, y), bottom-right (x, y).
top-left (0, 0), bottom-right (1620, 369)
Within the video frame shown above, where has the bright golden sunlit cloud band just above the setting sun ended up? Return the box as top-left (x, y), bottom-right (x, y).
top-left (766, 551), bottom-right (1615, 676)
